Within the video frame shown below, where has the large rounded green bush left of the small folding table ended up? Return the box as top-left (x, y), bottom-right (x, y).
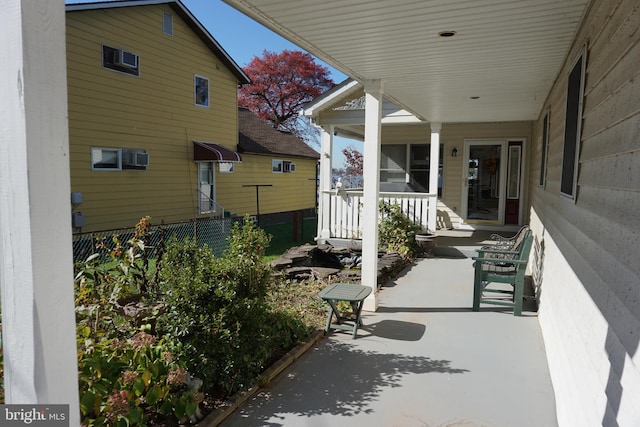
top-left (158, 217), bottom-right (309, 394)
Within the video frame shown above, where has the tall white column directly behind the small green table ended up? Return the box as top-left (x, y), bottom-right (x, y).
top-left (362, 80), bottom-right (383, 311)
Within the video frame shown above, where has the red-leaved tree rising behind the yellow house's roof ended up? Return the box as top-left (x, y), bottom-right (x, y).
top-left (238, 50), bottom-right (334, 142)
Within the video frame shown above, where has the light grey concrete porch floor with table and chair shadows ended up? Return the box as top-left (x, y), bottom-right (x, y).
top-left (222, 232), bottom-right (557, 427)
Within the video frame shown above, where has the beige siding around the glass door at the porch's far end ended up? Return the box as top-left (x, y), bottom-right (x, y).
top-left (382, 122), bottom-right (532, 227)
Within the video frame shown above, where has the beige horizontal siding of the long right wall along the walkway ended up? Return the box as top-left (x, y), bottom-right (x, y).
top-left (531, 0), bottom-right (640, 426)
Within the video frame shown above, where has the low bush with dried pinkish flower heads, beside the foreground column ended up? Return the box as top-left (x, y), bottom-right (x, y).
top-left (78, 326), bottom-right (203, 426)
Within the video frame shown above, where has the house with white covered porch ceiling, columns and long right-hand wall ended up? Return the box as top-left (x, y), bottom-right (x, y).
top-left (225, 0), bottom-right (640, 426)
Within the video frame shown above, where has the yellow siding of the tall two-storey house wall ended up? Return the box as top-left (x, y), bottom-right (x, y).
top-left (67, 5), bottom-right (237, 231)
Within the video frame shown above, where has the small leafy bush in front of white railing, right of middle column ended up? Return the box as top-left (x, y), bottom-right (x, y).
top-left (378, 201), bottom-right (420, 255)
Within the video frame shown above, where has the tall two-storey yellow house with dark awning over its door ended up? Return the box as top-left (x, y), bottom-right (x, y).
top-left (66, 0), bottom-right (253, 231)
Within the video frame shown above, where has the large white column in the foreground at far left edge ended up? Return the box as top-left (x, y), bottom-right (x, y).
top-left (0, 0), bottom-right (80, 426)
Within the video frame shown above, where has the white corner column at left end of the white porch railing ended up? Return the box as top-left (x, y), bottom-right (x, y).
top-left (317, 125), bottom-right (333, 243)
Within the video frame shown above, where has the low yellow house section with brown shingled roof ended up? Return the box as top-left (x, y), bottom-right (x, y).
top-left (218, 108), bottom-right (320, 221)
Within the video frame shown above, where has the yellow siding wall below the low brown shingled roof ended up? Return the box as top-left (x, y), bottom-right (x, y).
top-left (216, 153), bottom-right (317, 215)
